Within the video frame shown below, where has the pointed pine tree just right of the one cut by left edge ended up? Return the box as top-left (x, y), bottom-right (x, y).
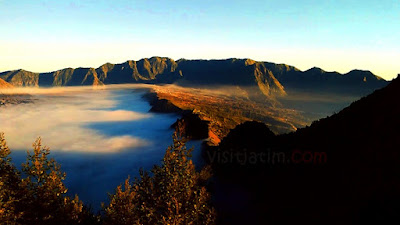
top-left (22, 138), bottom-right (85, 224)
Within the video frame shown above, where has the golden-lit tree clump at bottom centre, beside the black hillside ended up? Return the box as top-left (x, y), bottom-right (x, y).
top-left (104, 124), bottom-right (216, 225)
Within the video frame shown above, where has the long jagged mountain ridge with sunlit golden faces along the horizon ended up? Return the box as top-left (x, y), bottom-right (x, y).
top-left (0, 57), bottom-right (387, 97)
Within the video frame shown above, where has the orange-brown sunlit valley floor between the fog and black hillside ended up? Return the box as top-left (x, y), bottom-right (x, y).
top-left (146, 85), bottom-right (307, 145)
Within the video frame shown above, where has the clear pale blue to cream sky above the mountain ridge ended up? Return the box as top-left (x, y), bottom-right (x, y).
top-left (0, 0), bottom-right (400, 79)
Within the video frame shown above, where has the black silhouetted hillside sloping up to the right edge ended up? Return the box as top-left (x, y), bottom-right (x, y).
top-left (206, 74), bottom-right (400, 224)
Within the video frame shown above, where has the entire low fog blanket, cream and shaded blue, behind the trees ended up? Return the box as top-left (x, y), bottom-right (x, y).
top-left (0, 85), bottom-right (199, 209)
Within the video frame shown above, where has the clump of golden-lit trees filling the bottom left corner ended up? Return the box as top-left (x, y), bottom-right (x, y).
top-left (0, 134), bottom-right (96, 225)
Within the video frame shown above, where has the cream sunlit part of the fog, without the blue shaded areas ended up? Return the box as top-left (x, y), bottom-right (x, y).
top-left (0, 88), bottom-right (149, 153)
